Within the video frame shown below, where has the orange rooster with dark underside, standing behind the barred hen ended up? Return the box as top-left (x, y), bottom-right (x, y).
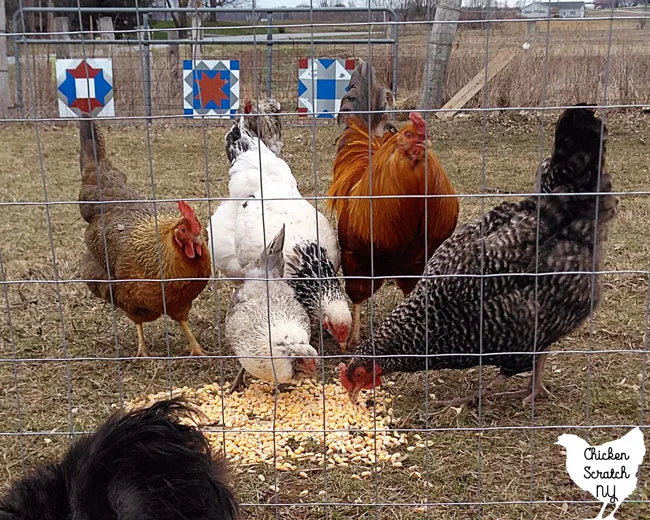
top-left (327, 64), bottom-right (458, 343)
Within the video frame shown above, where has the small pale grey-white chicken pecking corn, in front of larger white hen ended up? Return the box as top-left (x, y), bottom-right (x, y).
top-left (226, 226), bottom-right (318, 391)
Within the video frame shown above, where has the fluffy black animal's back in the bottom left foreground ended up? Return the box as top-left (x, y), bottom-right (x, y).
top-left (0, 400), bottom-right (239, 520)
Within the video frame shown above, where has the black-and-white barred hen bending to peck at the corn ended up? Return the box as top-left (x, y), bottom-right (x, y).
top-left (339, 108), bottom-right (618, 405)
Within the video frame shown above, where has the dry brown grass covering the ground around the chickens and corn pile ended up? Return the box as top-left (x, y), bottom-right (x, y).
top-left (0, 108), bottom-right (650, 520)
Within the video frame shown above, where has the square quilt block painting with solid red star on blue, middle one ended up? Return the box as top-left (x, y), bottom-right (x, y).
top-left (183, 60), bottom-right (239, 118)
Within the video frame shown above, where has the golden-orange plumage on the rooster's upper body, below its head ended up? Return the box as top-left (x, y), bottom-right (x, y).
top-left (328, 118), bottom-right (458, 249)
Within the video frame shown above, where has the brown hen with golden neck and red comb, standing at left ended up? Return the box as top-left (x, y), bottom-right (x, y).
top-left (79, 118), bottom-right (212, 356)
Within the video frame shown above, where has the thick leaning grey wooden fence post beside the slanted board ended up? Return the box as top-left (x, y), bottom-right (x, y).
top-left (420, 0), bottom-right (461, 110)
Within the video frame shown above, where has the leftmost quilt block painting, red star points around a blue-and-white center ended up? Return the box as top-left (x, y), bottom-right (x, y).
top-left (55, 58), bottom-right (115, 117)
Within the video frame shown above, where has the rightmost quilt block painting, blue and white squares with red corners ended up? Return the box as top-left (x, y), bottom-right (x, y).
top-left (298, 58), bottom-right (356, 119)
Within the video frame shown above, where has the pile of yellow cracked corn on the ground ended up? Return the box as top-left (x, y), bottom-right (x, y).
top-left (130, 379), bottom-right (408, 471)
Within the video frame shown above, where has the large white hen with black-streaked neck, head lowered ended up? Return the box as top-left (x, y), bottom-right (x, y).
top-left (208, 122), bottom-right (352, 346)
